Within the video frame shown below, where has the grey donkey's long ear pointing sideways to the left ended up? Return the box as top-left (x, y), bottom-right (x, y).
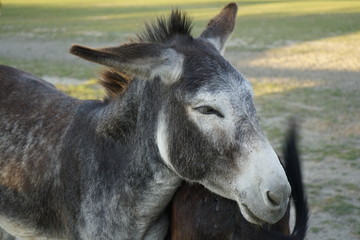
top-left (70, 43), bottom-right (184, 83)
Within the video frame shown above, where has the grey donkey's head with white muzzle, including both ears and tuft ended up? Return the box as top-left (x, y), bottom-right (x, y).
top-left (71, 3), bottom-right (291, 224)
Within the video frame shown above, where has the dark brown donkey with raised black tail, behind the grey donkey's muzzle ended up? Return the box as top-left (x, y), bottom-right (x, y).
top-left (168, 124), bottom-right (308, 240)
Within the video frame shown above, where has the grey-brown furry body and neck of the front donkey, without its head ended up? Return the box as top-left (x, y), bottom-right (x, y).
top-left (0, 66), bottom-right (180, 239)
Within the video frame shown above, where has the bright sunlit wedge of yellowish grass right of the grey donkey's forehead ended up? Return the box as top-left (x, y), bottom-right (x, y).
top-left (250, 31), bottom-right (360, 72)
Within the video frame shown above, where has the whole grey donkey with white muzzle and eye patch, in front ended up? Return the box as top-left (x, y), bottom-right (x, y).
top-left (0, 3), bottom-right (291, 239)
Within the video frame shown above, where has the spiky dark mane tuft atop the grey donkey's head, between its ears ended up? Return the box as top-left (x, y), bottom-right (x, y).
top-left (137, 9), bottom-right (192, 43)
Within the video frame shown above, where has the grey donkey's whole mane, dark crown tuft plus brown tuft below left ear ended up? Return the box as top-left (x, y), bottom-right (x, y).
top-left (99, 9), bottom-right (192, 99)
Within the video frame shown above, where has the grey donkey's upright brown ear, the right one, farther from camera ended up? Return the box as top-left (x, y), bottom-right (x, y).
top-left (200, 3), bottom-right (237, 53)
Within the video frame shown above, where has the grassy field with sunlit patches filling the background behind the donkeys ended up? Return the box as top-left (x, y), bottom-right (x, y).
top-left (0, 0), bottom-right (360, 240)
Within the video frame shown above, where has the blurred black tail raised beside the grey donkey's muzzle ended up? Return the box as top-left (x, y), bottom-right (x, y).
top-left (261, 121), bottom-right (309, 240)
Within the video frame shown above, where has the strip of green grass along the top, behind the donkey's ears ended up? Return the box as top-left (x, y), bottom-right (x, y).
top-left (0, 0), bottom-right (360, 44)
